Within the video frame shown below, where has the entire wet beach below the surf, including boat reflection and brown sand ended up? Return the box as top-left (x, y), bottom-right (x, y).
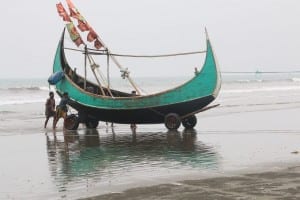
top-left (0, 103), bottom-right (300, 199)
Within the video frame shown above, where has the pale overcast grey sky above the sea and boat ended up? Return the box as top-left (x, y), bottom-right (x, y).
top-left (0, 0), bottom-right (300, 78)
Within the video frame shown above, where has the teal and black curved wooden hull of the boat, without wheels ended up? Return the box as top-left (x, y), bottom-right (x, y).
top-left (53, 30), bottom-right (221, 123)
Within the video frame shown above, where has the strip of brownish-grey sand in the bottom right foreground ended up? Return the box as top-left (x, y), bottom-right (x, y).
top-left (86, 165), bottom-right (300, 200)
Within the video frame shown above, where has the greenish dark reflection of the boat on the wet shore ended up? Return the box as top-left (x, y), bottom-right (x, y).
top-left (47, 128), bottom-right (218, 195)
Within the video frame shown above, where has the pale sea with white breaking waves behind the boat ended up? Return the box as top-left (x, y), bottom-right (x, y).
top-left (0, 73), bottom-right (300, 106)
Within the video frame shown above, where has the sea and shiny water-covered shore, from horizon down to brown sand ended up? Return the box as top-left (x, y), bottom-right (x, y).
top-left (0, 74), bottom-right (300, 199)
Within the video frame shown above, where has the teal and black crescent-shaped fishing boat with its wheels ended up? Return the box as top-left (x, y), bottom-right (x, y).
top-left (49, 0), bottom-right (221, 130)
